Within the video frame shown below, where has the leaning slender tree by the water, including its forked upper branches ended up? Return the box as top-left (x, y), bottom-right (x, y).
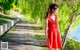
top-left (62, 5), bottom-right (79, 49)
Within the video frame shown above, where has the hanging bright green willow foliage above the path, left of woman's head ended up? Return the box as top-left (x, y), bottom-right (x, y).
top-left (18, 0), bottom-right (52, 21)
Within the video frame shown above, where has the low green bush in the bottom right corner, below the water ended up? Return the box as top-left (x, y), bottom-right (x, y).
top-left (65, 39), bottom-right (80, 50)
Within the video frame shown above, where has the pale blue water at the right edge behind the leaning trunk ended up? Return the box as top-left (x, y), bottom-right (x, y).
top-left (67, 25), bottom-right (80, 42)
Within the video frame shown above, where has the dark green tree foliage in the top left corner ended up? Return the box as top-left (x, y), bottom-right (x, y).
top-left (0, 0), bottom-right (15, 13)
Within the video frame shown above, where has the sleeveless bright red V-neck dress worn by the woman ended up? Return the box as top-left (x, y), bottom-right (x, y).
top-left (47, 15), bottom-right (62, 48)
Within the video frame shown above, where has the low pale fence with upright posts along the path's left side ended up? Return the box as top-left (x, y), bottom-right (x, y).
top-left (0, 18), bottom-right (20, 36)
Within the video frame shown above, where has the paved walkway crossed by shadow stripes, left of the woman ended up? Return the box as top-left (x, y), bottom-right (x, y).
top-left (0, 21), bottom-right (43, 50)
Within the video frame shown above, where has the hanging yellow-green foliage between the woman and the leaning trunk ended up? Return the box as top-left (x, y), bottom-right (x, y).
top-left (58, 4), bottom-right (71, 32)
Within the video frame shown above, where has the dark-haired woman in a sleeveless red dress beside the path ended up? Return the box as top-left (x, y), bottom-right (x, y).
top-left (45, 4), bottom-right (62, 50)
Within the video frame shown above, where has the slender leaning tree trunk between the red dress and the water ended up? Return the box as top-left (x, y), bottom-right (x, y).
top-left (62, 11), bottom-right (77, 50)
